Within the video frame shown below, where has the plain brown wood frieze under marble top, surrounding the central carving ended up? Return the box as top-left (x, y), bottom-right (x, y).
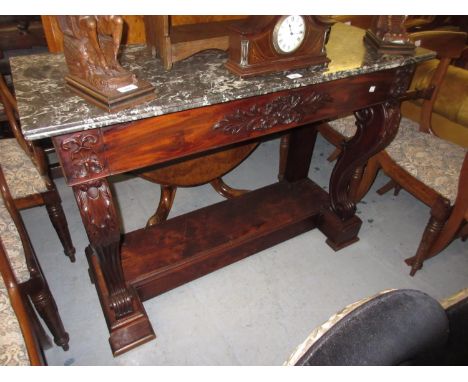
top-left (100, 70), bottom-right (394, 184)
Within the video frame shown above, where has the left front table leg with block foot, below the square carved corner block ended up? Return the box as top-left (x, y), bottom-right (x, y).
top-left (73, 179), bottom-right (155, 355)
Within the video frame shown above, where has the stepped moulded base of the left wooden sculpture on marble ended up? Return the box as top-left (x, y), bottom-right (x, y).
top-left (65, 75), bottom-right (155, 112)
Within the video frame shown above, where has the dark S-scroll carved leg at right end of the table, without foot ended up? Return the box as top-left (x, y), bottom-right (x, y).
top-left (330, 101), bottom-right (400, 221)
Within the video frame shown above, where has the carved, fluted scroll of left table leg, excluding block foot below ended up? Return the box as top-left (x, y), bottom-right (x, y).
top-left (73, 179), bottom-right (133, 319)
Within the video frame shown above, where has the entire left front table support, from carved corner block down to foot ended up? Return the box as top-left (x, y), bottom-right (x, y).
top-left (53, 129), bottom-right (155, 355)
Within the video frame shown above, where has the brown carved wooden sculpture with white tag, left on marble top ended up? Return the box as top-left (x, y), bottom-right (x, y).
top-left (58, 16), bottom-right (154, 111)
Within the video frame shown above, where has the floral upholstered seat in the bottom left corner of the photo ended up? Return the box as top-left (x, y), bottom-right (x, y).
top-left (0, 266), bottom-right (30, 366)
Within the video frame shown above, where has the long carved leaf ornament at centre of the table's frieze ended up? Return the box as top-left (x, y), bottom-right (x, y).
top-left (213, 92), bottom-right (333, 135)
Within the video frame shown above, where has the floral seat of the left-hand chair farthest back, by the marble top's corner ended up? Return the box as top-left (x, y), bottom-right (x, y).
top-left (0, 138), bottom-right (47, 199)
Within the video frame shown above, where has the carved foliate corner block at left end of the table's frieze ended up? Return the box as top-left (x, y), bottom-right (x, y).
top-left (60, 132), bottom-right (105, 179)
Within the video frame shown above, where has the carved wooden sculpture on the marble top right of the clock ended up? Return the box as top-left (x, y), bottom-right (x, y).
top-left (364, 16), bottom-right (415, 55)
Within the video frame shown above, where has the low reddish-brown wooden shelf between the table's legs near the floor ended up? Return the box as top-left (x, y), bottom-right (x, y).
top-left (121, 179), bottom-right (328, 300)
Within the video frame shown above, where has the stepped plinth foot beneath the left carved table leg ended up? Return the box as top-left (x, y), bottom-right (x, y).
top-left (86, 247), bottom-right (156, 356)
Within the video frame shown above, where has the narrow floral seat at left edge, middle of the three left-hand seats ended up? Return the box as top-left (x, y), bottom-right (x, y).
top-left (0, 196), bottom-right (30, 283)
